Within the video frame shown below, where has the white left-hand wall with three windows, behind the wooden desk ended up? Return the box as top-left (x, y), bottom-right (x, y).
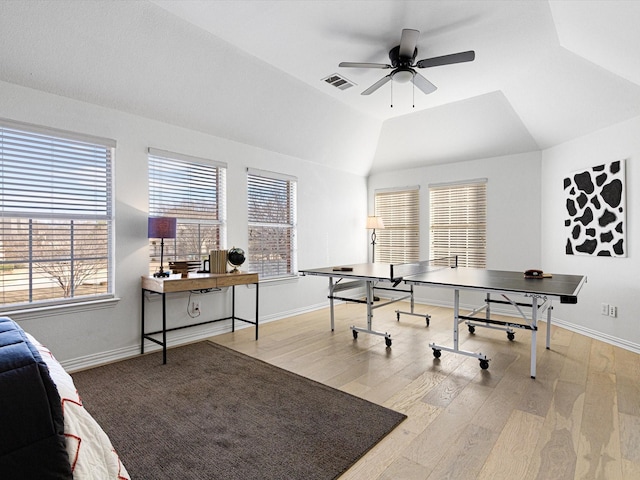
top-left (0, 82), bottom-right (367, 369)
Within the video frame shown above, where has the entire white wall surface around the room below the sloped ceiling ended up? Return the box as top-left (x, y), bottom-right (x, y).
top-left (0, 82), bottom-right (640, 367)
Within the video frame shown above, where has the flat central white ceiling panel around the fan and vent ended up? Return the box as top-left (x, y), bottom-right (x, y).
top-left (153, 0), bottom-right (559, 119)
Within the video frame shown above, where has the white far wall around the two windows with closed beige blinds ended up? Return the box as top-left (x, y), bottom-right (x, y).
top-left (368, 152), bottom-right (541, 305)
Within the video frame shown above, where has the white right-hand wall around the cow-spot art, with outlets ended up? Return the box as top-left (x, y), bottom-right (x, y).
top-left (541, 118), bottom-right (640, 352)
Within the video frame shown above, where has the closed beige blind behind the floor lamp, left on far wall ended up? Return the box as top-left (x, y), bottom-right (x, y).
top-left (375, 187), bottom-right (420, 263)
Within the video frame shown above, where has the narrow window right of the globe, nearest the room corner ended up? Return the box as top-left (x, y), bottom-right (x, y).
top-left (247, 169), bottom-right (297, 278)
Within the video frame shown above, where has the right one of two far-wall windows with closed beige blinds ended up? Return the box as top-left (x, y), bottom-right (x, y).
top-left (429, 180), bottom-right (487, 268)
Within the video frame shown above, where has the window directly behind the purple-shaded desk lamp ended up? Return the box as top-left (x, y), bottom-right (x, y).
top-left (149, 148), bottom-right (227, 272)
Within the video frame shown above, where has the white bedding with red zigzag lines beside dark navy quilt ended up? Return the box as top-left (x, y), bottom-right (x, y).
top-left (27, 333), bottom-right (131, 480)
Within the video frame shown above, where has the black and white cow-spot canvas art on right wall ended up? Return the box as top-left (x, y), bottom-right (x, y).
top-left (564, 160), bottom-right (627, 257)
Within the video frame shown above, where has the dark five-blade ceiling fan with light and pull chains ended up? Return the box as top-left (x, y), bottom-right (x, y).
top-left (339, 28), bottom-right (476, 95)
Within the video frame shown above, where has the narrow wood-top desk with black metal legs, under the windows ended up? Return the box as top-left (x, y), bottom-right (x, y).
top-left (140, 272), bottom-right (258, 364)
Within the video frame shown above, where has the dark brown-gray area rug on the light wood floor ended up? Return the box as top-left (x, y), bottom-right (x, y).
top-left (72, 342), bottom-right (406, 480)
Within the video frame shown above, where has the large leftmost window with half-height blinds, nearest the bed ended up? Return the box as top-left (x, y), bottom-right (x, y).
top-left (0, 121), bottom-right (115, 308)
